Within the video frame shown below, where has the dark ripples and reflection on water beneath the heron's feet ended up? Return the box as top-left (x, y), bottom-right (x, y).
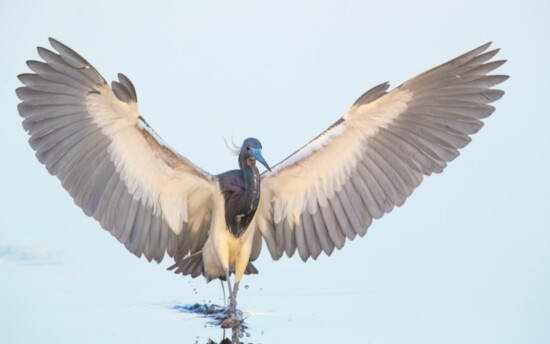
top-left (170, 303), bottom-right (251, 344)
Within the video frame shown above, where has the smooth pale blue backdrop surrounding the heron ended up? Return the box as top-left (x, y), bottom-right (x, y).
top-left (0, 0), bottom-right (550, 343)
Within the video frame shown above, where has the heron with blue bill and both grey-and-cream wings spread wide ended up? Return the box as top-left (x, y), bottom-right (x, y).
top-left (16, 38), bottom-right (508, 315)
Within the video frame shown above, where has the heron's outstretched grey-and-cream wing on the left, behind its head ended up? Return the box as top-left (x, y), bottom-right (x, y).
top-left (17, 39), bottom-right (216, 262)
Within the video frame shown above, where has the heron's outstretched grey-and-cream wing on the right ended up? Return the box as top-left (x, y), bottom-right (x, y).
top-left (255, 43), bottom-right (508, 261)
